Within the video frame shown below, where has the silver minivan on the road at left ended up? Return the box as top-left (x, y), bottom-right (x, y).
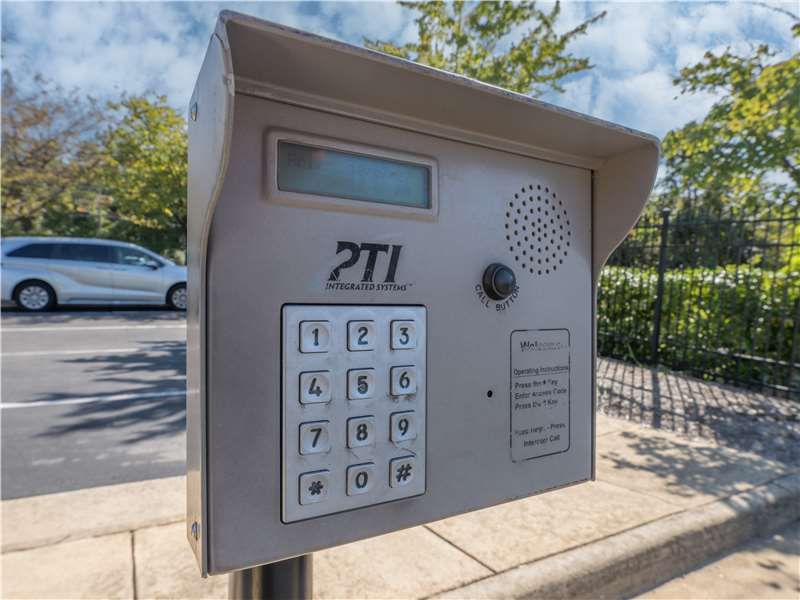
top-left (0, 237), bottom-right (186, 311)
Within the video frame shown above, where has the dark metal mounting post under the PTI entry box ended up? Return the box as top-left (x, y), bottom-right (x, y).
top-left (228, 554), bottom-right (314, 600)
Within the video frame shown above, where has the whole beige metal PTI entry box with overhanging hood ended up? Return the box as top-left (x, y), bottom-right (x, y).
top-left (187, 12), bottom-right (658, 574)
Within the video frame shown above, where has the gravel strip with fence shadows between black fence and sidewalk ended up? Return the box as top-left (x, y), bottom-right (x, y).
top-left (597, 359), bottom-right (800, 468)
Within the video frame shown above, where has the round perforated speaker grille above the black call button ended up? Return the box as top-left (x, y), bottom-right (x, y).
top-left (505, 183), bottom-right (572, 276)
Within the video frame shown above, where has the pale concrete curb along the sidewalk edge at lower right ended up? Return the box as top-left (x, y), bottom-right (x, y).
top-left (435, 474), bottom-right (800, 599)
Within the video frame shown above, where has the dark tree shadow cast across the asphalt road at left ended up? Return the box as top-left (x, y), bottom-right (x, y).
top-left (39, 341), bottom-right (186, 444)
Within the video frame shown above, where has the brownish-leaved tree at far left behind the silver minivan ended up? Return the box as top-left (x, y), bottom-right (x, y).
top-left (1, 70), bottom-right (106, 235)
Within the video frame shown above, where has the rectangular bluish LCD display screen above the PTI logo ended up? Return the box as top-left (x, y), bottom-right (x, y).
top-left (278, 141), bottom-right (431, 208)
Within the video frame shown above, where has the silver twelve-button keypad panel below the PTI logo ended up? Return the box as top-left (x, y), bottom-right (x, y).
top-left (282, 305), bottom-right (426, 523)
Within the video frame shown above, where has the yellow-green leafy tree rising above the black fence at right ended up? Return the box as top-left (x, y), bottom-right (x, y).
top-left (660, 17), bottom-right (800, 208)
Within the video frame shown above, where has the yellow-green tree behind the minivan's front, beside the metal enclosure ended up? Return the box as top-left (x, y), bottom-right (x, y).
top-left (102, 96), bottom-right (188, 254)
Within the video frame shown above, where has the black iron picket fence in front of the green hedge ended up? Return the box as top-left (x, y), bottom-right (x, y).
top-left (598, 206), bottom-right (800, 398)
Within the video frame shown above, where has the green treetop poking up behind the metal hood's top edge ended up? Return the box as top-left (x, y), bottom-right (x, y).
top-left (364, 1), bottom-right (606, 96)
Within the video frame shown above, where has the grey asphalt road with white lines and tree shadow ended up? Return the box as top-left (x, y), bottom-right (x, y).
top-left (0, 310), bottom-right (186, 499)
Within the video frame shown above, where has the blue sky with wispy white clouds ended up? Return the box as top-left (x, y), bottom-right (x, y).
top-left (0, 1), bottom-right (800, 136)
